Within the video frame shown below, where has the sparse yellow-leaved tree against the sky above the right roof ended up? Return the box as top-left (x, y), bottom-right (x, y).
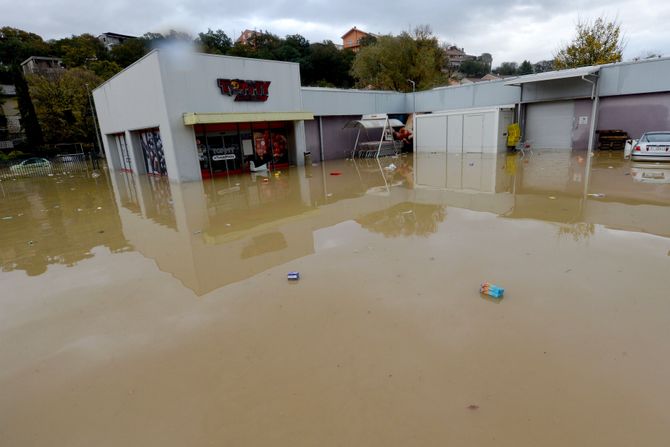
top-left (554, 17), bottom-right (624, 70)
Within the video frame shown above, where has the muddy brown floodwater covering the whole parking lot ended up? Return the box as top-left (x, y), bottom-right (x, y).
top-left (0, 151), bottom-right (670, 447)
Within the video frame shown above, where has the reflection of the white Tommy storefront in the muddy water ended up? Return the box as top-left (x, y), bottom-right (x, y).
top-left (112, 160), bottom-right (411, 295)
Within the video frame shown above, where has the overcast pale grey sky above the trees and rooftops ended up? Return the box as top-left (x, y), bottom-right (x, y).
top-left (0, 0), bottom-right (670, 66)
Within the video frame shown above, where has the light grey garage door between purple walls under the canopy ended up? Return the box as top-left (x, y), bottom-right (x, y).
top-left (526, 101), bottom-right (575, 149)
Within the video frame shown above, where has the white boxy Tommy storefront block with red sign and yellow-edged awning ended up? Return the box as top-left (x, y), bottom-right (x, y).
top-left (93, 50), bottom-right (313, 181)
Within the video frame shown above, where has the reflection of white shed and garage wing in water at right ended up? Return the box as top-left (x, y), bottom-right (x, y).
top-left (415, 151), bottom-right (670, 239)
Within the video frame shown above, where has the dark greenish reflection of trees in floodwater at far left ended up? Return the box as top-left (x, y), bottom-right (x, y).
top-left (0, 176), bottom-right (131, 276)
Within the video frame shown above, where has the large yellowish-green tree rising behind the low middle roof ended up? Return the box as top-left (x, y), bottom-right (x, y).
top-left (351, 27), bottom-right (446, 92)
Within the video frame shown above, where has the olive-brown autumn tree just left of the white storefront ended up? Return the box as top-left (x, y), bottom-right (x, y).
top-left (28, 68), bottom-right (102, 143)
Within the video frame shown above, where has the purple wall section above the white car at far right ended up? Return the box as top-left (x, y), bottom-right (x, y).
top-left (597, 92), bottom-right (670, 138)
